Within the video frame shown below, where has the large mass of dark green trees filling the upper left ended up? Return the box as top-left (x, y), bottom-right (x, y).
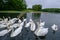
top-left (0, 0), bottom-right (27, 10)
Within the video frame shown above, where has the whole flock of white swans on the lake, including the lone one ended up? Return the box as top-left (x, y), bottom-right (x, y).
top-left (0, 18), bottom-right (58, 37)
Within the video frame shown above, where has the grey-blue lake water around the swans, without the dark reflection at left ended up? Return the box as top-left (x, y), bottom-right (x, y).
top-left (0, 12), bottom-right (60, 40)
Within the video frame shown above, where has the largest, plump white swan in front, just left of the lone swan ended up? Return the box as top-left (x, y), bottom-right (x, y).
top-left (34, 21), bottom-right (48, 36)
